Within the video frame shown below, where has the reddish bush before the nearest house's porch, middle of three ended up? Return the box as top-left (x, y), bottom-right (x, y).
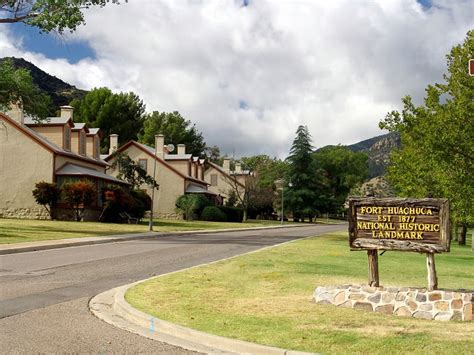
top-left (62, 181), bottom-right (96, 222)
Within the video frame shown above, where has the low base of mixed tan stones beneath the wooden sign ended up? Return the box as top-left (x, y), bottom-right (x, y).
top-left (313, 285), bottom-right (474, 321)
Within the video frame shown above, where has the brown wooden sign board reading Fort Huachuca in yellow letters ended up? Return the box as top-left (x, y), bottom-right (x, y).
top-left (349, 197), bottom-right (450, 253)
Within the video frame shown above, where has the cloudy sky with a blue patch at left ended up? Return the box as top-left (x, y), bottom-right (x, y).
top-left (0, 0), bottom-right (474, 158)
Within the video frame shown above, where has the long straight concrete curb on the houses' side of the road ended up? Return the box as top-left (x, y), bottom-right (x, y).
top-left (0, 224), bottom-right (322, 255)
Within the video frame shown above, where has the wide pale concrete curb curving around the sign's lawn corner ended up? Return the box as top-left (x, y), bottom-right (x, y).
top-left (89, 278), bottom-right (311, 355)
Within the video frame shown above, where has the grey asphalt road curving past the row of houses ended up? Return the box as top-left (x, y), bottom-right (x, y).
top-left (0, 225), bottom-right (346, 354)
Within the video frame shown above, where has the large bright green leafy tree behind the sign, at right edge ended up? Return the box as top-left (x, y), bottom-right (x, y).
top-left (380, 30), bottom-right (474, 244)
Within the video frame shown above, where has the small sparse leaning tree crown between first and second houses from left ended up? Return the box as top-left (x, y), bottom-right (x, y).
top-left (111, 153), bottom-right (159, 190)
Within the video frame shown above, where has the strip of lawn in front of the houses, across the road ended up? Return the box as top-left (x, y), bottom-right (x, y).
top-left (0, 219), bottom-right (312, 244)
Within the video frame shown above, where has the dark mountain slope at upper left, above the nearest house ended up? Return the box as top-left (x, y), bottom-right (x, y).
top-left (0, 57), bottom-right (87, 109)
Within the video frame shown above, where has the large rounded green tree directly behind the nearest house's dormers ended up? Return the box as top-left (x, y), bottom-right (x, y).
top-left (71, 87), bottom-right (145, 153)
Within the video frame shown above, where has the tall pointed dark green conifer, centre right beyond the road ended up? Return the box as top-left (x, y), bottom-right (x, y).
top-left (284, 126), bottom-right (329, 220)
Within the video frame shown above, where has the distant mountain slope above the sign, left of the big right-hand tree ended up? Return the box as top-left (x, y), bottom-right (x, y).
top-left (347, 133), bottom-right (400, 179)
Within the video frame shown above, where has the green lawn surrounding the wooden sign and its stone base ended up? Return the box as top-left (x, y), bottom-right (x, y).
top-left (126, 232), bottom-right (474, 354)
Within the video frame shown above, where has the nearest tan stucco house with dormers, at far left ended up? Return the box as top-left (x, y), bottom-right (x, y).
top-left (0, 106), bottom-right (124, 219)
